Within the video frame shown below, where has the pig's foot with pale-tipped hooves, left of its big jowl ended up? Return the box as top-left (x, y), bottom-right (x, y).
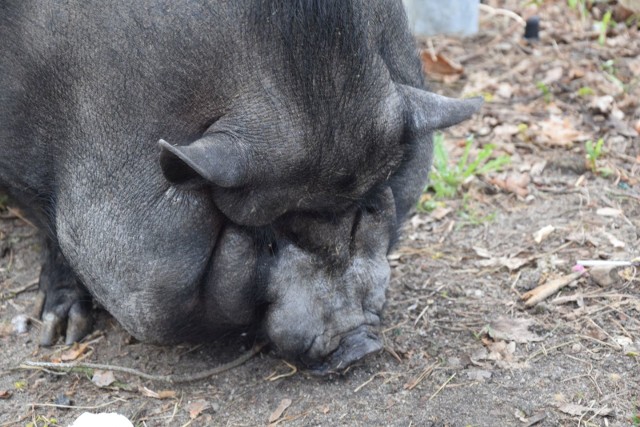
top-left (36, 244), bottom-right (93, 347)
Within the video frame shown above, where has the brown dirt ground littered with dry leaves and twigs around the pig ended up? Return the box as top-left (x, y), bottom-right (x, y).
top-left (0, 0), bottom-right (640, 426)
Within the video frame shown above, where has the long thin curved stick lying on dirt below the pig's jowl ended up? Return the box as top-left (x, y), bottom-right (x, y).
top-left (20, 344), bottom-right (265, 384)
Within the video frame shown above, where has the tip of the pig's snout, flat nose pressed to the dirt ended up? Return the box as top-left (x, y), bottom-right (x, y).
top-left (308, 325), bottom-right (382, 375)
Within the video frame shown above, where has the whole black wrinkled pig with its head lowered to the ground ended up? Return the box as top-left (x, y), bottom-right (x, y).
top-left (0, 0), bottom-right (480, 373)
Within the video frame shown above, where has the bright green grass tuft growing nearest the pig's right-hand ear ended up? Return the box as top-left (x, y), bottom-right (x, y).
top-left (419, 132), bottom-right (511, 211)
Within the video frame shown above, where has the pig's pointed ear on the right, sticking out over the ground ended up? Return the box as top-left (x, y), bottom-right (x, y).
top-left (397, 85), bottom-right (483, 130)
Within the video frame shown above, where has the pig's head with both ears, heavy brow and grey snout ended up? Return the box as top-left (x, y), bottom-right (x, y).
top-left (161, 85), bottom-right (481, 373)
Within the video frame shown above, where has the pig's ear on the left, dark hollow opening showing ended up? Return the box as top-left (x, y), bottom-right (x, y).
top-left (158, 134), bottom-right (247, 188)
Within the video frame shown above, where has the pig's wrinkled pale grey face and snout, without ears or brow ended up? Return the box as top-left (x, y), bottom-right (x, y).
top-left (264, 187), bottom-right (395, 373)
